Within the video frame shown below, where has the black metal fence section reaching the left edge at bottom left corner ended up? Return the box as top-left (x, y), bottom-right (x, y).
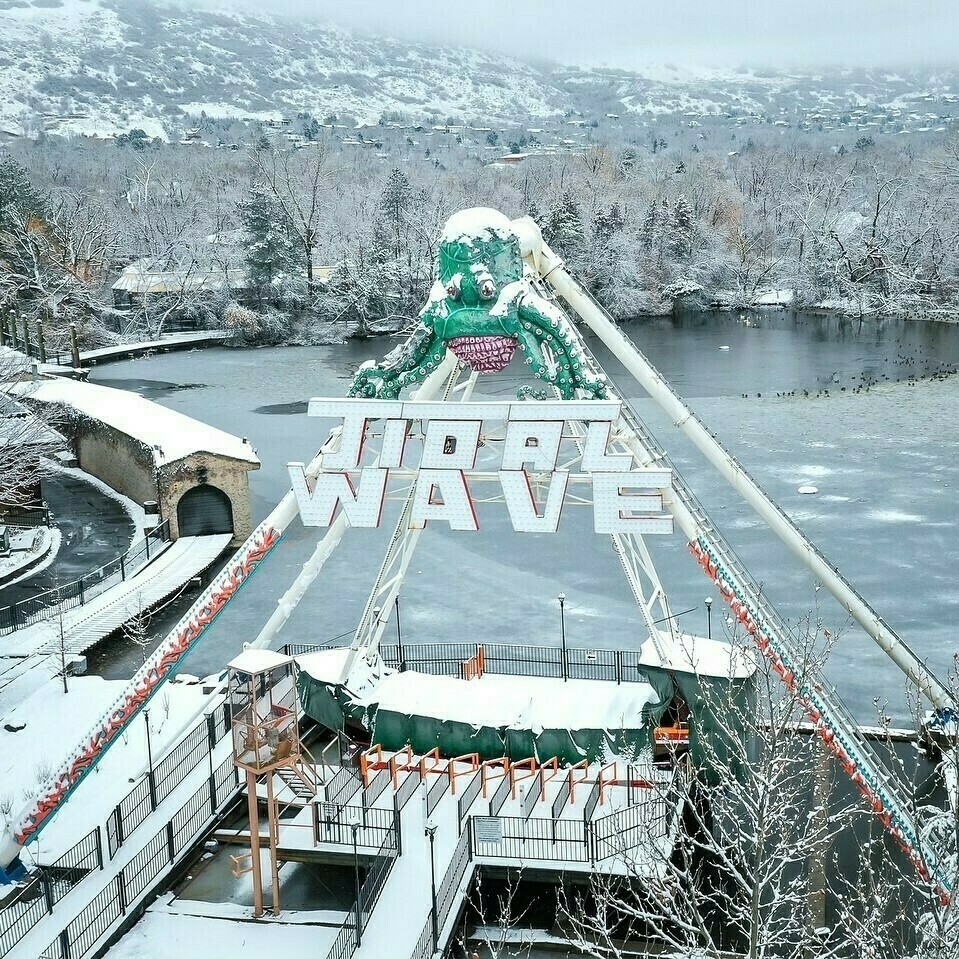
top-left (0, 828), bottom-right (103, 956)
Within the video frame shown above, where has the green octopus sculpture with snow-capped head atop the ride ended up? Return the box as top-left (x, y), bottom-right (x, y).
top-left (350, 208), bottom-right (607, 400)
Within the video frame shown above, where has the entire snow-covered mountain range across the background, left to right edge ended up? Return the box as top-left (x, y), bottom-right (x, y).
top-left (0, 0), bottom-right (959, 136)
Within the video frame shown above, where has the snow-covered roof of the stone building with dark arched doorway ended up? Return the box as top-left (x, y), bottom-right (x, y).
top-left (7, 378), bottom-right (260, 468)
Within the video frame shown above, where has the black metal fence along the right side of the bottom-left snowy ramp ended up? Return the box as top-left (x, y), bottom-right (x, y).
top-left (39, 756), bottom-right (238, 959)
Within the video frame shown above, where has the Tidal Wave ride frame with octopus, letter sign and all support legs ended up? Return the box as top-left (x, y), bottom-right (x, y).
top-left (0, 209), bottom-right (954, 899)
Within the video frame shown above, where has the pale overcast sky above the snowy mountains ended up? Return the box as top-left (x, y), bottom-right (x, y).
top-left (197, 0), bottom-right (959, 67)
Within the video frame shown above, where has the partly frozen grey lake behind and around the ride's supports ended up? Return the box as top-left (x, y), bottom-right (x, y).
top-left (90, 313), bottom-right (959, 722)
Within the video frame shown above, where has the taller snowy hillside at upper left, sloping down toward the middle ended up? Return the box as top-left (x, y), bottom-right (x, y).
top-left (0, 0), bottom-right (564, 135)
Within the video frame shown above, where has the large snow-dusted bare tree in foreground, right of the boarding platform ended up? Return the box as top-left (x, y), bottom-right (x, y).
top-left (560, 643), bottom-right (847, 959)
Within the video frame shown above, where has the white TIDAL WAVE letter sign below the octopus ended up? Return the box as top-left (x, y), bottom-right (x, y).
top-left (288, 399), bottom-right (673, 534)
